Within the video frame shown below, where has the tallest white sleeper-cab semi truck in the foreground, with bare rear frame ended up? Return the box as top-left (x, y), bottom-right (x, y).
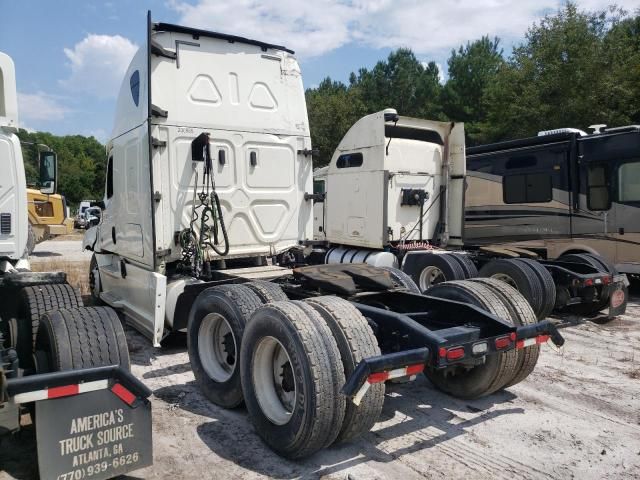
top-left (84, 14), bottom-right (563, 457)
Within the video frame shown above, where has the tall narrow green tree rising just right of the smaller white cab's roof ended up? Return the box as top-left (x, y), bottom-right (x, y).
top-left (442, 36), bottom-right (505, 144)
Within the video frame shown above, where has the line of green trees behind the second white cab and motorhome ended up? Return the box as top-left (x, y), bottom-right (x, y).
top-left (306, 3), bottom-right (640, 166)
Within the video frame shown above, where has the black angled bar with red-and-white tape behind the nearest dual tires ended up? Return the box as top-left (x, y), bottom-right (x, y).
top-left (342, 347), bottom-right (429, 405)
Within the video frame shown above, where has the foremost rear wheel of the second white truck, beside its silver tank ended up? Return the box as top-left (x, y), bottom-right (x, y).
top-left (402, 252), bottom-right (466, 293)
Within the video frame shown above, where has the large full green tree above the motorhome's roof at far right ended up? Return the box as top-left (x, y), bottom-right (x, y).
top-left (482, 3), bottom-right (640, 140)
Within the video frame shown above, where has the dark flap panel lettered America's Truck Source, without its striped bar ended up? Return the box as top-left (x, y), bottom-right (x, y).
top-left (36, 390), bottom-right (153, 480)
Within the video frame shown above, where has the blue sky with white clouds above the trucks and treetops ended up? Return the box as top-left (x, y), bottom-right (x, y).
top-left (0, 0), bottom-right (638, 142)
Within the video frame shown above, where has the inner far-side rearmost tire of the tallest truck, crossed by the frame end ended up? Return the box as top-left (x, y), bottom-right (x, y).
top-left (425, 280), bottom-right (518, 399)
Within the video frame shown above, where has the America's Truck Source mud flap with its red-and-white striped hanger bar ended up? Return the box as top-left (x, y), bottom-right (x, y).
top-left (7, 366), bottom-right (153, 480)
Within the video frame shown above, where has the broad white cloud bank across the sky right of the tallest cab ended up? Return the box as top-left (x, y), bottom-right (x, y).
top-left (169, 0), bottom-right (637, 57)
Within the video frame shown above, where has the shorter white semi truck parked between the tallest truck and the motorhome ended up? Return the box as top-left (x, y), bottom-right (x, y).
top-left (313, 109), bottom-right (628, 321)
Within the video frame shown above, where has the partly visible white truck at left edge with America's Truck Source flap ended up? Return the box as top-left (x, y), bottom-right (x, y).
top-left (0, 52), bottom-right (152, 480)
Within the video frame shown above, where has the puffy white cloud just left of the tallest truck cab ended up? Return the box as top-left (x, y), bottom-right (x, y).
top-left (61, 34), bottom-right (138, 98)
